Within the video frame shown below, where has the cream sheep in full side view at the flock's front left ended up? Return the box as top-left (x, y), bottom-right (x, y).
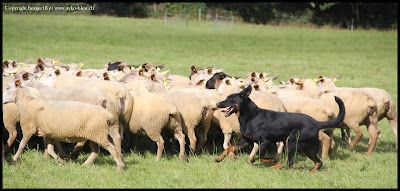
top-left (3, 80), bottom-right (125, 169)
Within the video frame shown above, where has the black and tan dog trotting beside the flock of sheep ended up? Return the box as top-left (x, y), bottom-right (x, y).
top-left (216, 86), bottom-right (345, 172)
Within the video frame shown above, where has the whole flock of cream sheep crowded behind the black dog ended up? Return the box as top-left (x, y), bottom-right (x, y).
top-left (2, 58), bottom-right (397, 169)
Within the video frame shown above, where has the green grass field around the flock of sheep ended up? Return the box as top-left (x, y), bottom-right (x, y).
top-left (2, 14), bottom-right (398, 188)
